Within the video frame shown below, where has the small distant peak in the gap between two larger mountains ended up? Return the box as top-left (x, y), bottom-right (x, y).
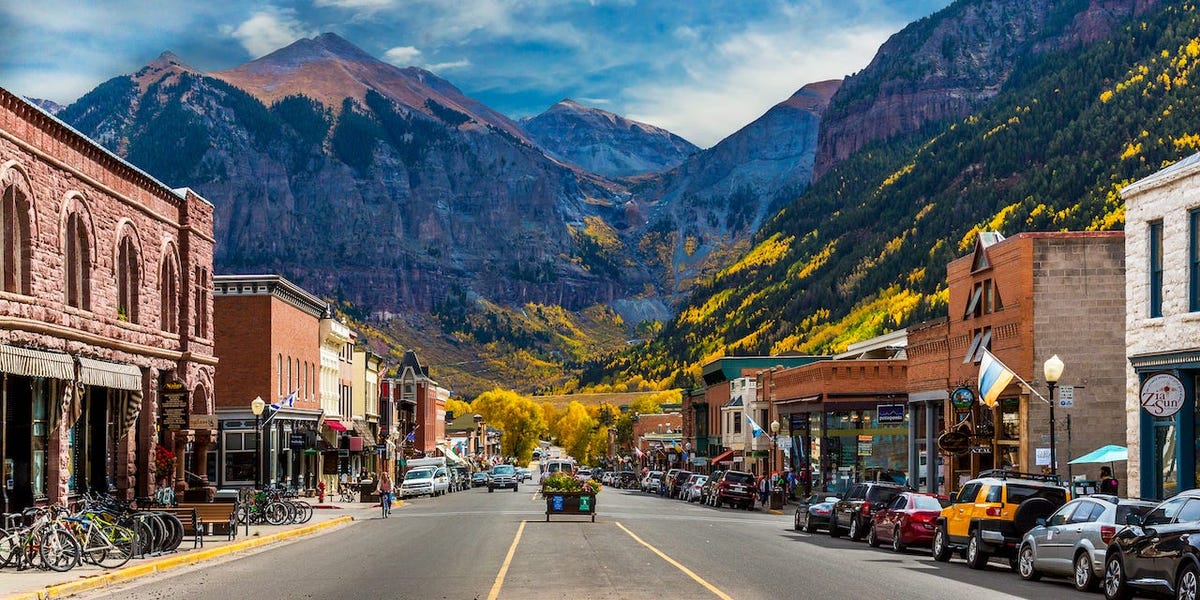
top-left (521, 98), bottom-right (700, 179)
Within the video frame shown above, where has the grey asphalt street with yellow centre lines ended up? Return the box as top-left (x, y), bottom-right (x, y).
top-left (60, 485), bottom-right (1096, 600)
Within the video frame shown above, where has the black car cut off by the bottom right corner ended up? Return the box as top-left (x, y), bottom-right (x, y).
top-left (1104, 490), bottom-right (1200, 600)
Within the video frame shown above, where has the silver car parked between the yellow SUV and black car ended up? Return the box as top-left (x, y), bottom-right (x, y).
top-left (1016, 494), bottom-right (1154, 592)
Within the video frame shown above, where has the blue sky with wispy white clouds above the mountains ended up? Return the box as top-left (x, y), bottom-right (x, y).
top-left (0, 0), bottom-right (950, 146)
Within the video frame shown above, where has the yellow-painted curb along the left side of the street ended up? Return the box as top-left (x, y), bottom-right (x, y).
top-left (4, 516), bottom-right (354, 600)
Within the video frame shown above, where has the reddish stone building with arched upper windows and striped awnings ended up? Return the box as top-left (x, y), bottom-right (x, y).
top-left (0, 89), bottom-right (216, 512)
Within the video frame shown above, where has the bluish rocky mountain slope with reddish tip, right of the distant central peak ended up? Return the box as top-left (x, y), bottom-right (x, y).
top-left (632, 80), bottom-right (841, 295)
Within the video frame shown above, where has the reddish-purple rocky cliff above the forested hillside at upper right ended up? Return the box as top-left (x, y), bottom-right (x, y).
top-left (814, 0), bottom-right (1164, 179)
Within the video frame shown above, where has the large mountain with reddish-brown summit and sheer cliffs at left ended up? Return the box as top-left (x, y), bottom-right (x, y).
top-left (60, 34), bottom-right (646, 311)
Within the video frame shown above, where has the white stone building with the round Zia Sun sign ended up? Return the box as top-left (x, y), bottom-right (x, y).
top-left (1121, 154), bottom-right (1200, 498)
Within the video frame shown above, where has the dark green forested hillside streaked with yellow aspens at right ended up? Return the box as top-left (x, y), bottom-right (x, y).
top-left (584, 5), bottom-right (1200, 386)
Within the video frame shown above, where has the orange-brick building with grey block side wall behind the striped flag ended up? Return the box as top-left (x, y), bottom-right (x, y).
top-left (908, 232), bottom-right (1126, 492)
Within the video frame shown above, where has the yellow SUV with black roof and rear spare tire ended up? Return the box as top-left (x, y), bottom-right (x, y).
top-left (934, 470), bottom-right (1070, 570)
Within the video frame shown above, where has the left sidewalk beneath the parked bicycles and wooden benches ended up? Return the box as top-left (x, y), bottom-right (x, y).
top-left (0, 500), bottom-right (403, 600)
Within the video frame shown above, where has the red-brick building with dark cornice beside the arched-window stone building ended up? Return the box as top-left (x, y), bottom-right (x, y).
top-left (208, 275), bottom-right (329, 488)
